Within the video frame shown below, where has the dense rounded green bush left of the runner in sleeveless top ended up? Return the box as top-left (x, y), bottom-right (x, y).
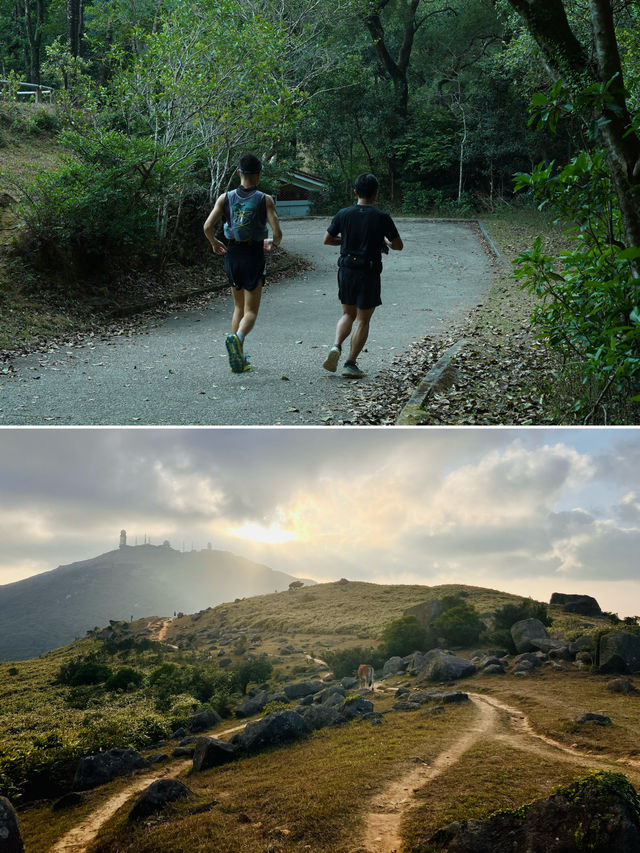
top-left (17, 126), bottom-right (182, 279)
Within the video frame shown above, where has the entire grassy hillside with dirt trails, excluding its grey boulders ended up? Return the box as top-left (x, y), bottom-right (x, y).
top-left (0, 580), bottom-right (640, 853)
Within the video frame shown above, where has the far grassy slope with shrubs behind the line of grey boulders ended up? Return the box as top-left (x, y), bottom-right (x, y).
top-left (0, 581), bottom-right (608, 798)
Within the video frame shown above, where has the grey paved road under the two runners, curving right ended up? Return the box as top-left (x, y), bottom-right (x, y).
top-left (0, 218), bottom-right (491, 425)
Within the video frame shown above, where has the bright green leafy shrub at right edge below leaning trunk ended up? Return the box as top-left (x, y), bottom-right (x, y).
top-left (515, 150), bottom-right (640, 423)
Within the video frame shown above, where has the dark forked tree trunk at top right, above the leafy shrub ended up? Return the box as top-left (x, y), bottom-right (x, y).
top-left (508, 0), bottom-right (640, 251)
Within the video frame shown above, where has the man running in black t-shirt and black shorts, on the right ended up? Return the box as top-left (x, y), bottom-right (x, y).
top-left (323, 175), bottom-right (403, 379)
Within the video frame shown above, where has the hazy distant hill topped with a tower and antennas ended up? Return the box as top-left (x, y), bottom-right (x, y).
top-left (0, 530), bottom-right (314, 660)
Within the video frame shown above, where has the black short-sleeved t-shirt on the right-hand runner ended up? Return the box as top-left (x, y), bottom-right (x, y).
top-left (327, 204), bottom-right (400, 270)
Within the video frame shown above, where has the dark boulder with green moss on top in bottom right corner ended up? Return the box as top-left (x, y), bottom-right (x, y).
top-left (430, 772), bottom-right (640, 853)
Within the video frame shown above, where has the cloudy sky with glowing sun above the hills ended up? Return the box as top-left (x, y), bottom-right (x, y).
top-left (0, 427), bottom-right (640, 616)
